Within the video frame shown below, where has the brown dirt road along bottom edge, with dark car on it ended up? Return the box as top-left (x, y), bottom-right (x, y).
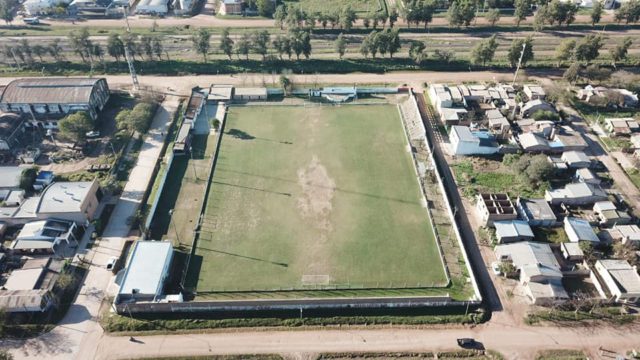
top-left (96, 322), bottom-right (640, 360)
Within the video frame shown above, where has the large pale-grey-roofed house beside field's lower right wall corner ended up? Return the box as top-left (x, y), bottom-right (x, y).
top-left (495, 241), bottom-right (569, 306)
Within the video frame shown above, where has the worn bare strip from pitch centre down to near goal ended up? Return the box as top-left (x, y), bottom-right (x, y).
top-left (297, 155), bottom-right (336, 285)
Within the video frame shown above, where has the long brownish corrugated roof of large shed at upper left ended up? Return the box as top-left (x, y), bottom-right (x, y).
top-left (0, 78), bottom-right (104, 104)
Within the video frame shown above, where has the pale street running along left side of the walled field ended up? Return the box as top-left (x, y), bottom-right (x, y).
top-left (0, 96), bottom-right (179, 359)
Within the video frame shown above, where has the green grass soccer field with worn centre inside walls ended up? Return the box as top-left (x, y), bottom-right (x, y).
top-left (187, 105), bottom-right (447, 294)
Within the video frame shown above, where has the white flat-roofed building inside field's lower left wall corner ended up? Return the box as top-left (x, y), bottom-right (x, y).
top-left (115, 241), bottom-right (173, 304)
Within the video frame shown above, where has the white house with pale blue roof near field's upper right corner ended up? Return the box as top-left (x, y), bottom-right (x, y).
top-left (449, 125), bottom-right (500, 155)
